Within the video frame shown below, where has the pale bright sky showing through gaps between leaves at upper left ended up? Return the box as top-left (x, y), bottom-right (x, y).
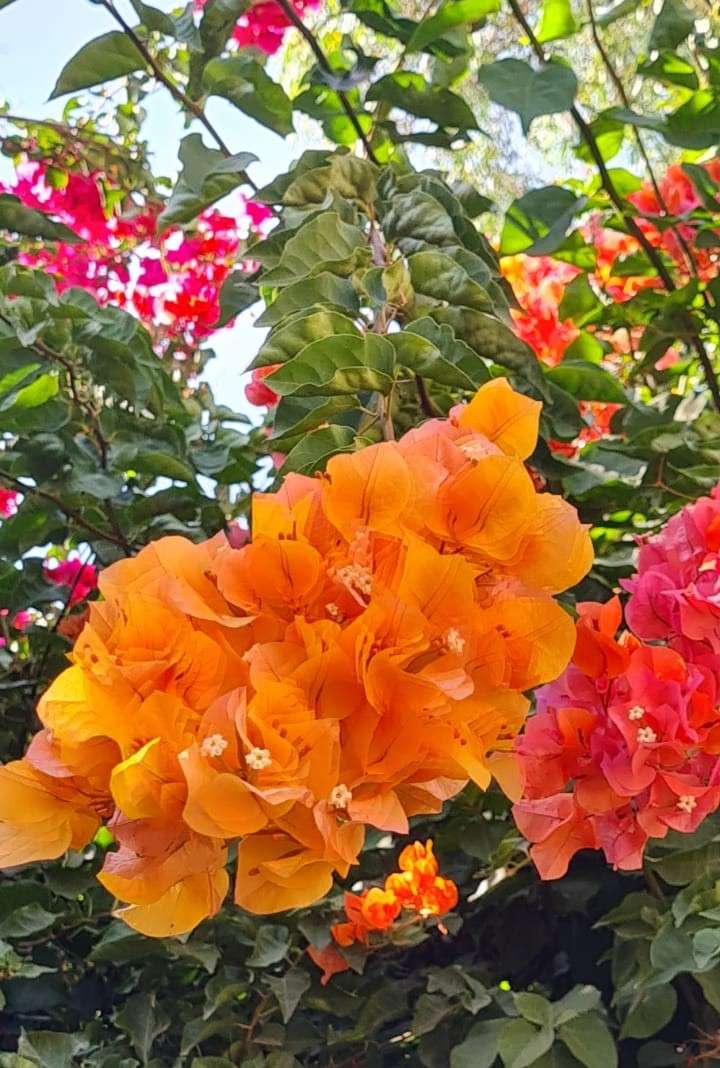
top-left (0, 0), bottom-right (304, 413)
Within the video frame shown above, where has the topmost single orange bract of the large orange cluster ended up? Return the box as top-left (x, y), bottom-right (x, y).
top-left (458, 378), bottom-right (543, 460)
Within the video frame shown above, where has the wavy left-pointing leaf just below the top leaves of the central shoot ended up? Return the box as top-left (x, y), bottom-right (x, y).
top-left (261, 211), bottom-right (370, 285)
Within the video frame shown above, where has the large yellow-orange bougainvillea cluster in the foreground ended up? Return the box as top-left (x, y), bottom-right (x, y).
top-left (0, 379), bottom-right (592, 936)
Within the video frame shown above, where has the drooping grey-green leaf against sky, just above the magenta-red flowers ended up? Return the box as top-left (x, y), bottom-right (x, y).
top-left (158, 134), bottom-right (257, 231)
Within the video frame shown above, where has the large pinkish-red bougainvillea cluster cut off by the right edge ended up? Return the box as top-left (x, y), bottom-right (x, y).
top-left (514, 488), bottom-right (720, 878)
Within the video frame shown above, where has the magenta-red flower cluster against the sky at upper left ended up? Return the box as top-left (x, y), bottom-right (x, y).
top-left (9, 161), bottom-right (270, 361)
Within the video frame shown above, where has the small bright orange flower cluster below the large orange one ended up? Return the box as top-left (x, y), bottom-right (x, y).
top-left (308, 838), bottom-right (450, 986)
